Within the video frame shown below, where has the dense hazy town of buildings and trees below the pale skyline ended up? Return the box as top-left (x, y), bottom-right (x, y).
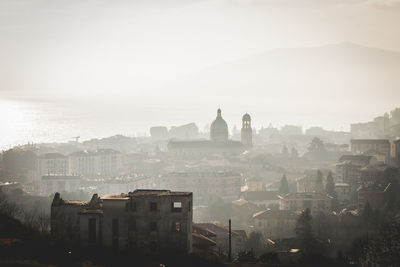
top-left (0, 108), bottom-right (400, 266)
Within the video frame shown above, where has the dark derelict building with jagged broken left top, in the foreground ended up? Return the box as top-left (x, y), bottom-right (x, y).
top-left (51, 190), bottom-right (193, 253)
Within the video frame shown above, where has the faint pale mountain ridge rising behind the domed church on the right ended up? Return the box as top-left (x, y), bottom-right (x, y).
top-left (162, 43), bottom-right (400, 100)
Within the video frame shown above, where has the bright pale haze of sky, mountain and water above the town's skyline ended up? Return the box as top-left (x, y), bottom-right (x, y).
top-left (0, 0), bottom-right (400, 147)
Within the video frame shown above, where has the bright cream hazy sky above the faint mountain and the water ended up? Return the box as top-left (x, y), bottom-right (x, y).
top-left (0, 0), bottom-right (400, 146)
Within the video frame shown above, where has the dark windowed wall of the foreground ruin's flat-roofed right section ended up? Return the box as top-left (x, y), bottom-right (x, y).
top-left (102, 195), bottom-right (193, 253)
